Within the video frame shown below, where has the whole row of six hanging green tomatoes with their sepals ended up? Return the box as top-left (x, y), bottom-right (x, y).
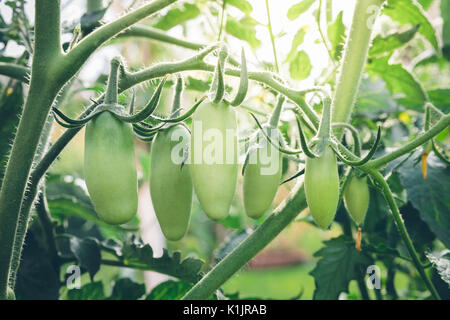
top-left (53, 48), bottom-right (379, 245)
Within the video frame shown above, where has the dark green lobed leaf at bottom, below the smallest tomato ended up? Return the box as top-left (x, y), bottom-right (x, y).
top-left (310, 236), bottom-right (373, 300)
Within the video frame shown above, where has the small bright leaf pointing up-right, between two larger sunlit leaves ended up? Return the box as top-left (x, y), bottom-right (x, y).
top-left (369, 26), bottom-right (419, 57)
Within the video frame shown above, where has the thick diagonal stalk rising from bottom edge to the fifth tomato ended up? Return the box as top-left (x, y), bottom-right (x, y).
top-left (183, 183), bottom-right (306, 300)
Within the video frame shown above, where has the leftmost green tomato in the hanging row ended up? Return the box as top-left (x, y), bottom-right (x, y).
top-left (84, 111), bottom-right (138, 224)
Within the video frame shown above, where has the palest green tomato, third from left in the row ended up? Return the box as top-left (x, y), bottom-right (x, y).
top-left (190, 103), bottom-right (238, 220)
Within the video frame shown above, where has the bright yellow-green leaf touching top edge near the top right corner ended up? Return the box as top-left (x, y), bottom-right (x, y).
top-left (383, 0), bottom-right (439, 51)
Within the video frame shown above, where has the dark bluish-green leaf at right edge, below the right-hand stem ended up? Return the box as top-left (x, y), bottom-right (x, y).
top-left (399, 150), bottom-right (450, 247)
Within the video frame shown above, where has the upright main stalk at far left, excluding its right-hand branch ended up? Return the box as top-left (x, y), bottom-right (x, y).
top-left (0, 0), bottom-right (61, 299)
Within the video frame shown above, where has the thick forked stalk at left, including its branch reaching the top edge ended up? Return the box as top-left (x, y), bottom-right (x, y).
top-left (0, 0), bottom-right (176, 299)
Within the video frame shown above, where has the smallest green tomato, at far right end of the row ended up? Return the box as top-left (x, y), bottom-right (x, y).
top-left (344, 176), bottom-right (370, 226)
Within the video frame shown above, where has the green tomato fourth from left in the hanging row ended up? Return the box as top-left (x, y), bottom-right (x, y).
top-left (243, 132), bottom-right (283, 219)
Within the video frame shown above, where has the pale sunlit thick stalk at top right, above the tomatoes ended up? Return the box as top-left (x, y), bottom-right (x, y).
top-left (332, 0), bottom-right (383, 131)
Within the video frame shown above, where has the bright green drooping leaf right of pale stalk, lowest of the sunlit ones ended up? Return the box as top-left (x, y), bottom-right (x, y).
top-left (366, 56), bottom-right (426, 111)
